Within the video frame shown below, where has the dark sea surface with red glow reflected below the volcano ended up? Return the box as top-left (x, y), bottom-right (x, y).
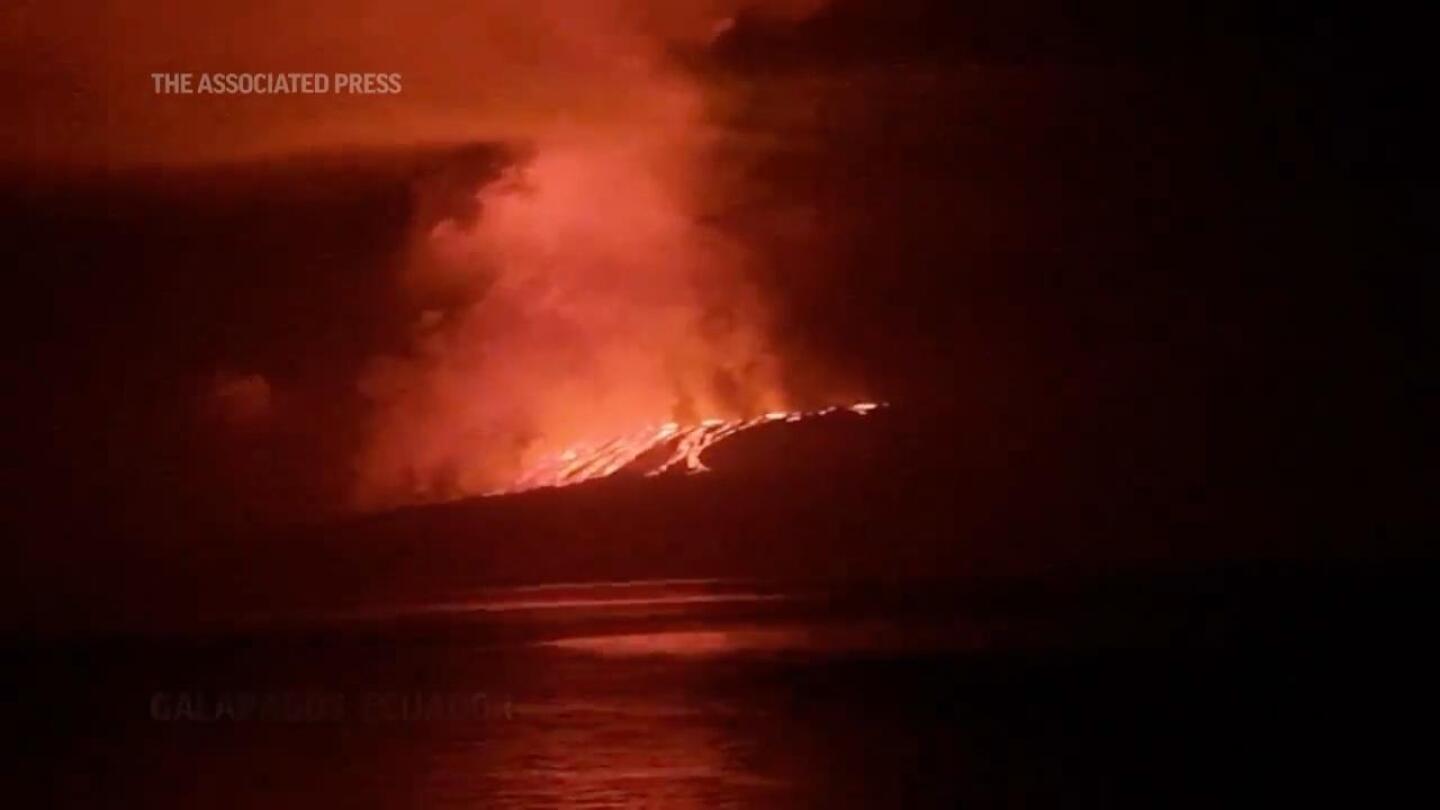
top-left (9, 567), bottom-right (1428, 807)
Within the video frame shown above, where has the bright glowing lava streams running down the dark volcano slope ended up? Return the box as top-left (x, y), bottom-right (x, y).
top-left (487, 402), bottom-right (884, 494)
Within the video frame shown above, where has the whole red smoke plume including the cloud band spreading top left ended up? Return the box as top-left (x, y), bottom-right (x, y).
top-left (0, 0), bottom-right (822, 509)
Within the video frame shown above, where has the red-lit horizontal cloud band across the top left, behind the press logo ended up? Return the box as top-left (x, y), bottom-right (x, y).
top-left (0, 0), bottom-right (821, 166)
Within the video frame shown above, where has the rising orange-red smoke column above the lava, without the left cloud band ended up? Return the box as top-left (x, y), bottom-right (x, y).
top-left (354, 4), bottom-right (829, 507)
